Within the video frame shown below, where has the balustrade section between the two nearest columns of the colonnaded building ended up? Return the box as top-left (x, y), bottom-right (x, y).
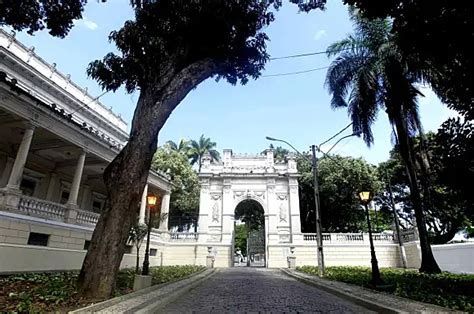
top-left (18, 196), bottom-right (67, 221)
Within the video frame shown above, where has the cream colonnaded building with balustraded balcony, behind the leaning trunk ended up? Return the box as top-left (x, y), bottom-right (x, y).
top-left (0, 30), bottom-right (171, 272)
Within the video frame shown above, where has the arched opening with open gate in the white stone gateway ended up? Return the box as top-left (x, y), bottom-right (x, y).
top-left (233, 199), bottom-right (267, 267)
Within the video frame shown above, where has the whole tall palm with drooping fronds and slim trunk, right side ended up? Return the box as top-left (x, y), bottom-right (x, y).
top-left (325, 9), bottom-right (440, 273)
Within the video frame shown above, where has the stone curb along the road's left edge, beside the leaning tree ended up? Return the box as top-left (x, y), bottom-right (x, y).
top-left (68, 269), bottom-right (216, 314)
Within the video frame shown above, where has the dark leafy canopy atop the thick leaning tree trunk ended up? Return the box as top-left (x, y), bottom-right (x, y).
top-left (88, 0), bottom-right (286, 92)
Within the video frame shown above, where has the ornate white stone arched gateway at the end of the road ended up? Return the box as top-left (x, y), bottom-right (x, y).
top-left (199, 149), bottom-right (302, 267)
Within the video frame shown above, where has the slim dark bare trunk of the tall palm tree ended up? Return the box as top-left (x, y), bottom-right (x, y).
top-left (391, 109), bottom-right (441, 273)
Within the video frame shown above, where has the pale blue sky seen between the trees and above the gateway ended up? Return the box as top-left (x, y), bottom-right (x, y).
top-left (9, 0), bottom-right (456, 164)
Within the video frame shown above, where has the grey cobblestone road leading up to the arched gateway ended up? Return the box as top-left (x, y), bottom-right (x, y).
top-left (159, 268), bottom-right (370, 313)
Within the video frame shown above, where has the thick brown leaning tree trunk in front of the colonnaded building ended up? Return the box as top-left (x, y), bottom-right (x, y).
top-left (78, 59), bottom-right (217, 299)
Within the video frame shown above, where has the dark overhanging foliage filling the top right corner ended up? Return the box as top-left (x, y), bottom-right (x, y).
top-left (344, 0), bottom-right (474, 120)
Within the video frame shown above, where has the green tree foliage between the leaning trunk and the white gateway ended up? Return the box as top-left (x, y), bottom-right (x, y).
top-left (152, 145), bottom-right (200, 224)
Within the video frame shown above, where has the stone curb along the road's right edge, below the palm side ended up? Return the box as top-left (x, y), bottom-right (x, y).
top-left (280, 268), bottom-right (459, 313)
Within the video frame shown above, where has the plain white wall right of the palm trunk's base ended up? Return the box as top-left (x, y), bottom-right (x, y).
top-left (431, 243), bottom-right (474, 274)
